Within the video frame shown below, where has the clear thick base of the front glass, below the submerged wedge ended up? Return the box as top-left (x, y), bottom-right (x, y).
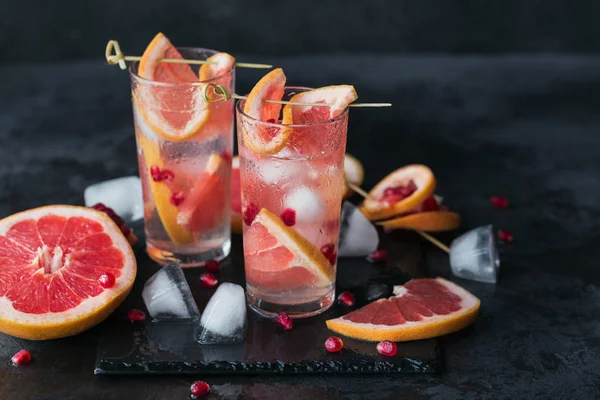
top-left (246, 288), bottom-right (335, 318)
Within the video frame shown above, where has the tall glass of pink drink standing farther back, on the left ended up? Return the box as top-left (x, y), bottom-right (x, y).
top-left (130, 48), bottom-right (235, 267)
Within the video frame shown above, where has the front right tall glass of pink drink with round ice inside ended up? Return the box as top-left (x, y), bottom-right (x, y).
top-left (236, 87), bottom-right (348, 318)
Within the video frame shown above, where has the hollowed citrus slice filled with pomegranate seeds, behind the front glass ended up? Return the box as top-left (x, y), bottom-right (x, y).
top-left (360, 164), bottom-right (436, 221)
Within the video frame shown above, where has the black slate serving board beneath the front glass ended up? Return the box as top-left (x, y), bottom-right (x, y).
top-left (95, 227), bottom-right (442, 375)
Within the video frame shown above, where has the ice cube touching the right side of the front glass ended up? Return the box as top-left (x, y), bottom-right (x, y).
top-left (338, 201), bottom-right (379, 257)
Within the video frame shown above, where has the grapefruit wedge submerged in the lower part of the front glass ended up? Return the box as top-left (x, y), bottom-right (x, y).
top-left (244, 208), bottom-right (335, 290)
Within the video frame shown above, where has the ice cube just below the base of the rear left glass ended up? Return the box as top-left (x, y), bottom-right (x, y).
top-left (142, 262), bottom-right (200, 320)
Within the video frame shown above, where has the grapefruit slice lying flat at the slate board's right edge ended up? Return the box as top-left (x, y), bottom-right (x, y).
top-left (326, 278), bottom-right (479, 342)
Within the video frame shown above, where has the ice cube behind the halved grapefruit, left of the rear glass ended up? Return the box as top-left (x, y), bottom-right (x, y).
top-left (83, 176), bottom-right (144, 223)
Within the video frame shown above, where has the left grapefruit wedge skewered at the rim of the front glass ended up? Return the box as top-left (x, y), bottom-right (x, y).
top-left (238, 68), bottom-right (289, 155)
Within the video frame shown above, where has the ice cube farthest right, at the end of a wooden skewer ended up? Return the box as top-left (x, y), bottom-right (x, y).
top-left (450, 225), bottom-right (500, 283)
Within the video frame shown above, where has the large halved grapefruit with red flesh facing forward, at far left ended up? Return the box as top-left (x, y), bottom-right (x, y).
top-left (0, 205), bottom-right (136, 340)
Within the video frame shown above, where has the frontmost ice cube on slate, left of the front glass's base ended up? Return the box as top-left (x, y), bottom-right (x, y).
top-left (198, 282), bottom-right (247, 344)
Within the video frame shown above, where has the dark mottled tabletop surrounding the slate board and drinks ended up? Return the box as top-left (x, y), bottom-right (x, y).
top-left (0, 56), bottom-right (600, 400)
